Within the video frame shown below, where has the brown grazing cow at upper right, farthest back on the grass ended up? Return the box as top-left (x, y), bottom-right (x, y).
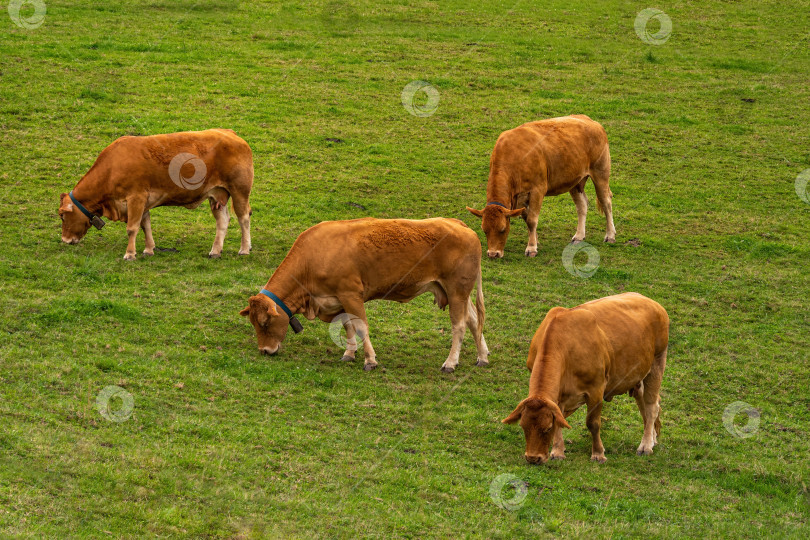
top-left (467, 114), bottom-right (616, 259)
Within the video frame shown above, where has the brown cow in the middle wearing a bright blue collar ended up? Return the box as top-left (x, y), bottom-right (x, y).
top-left (240, 218), bottom-right (489, 373)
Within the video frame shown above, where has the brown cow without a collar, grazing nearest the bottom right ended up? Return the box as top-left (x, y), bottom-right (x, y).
top-left (503, 293), bottom-right (669, 463)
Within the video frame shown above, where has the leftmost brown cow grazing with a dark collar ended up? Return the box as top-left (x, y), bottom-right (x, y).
top-left (59, 129), bottom-right (253, 261)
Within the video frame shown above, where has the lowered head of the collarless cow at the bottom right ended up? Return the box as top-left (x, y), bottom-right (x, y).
top-left (501, 397), bottom-right (571, 463)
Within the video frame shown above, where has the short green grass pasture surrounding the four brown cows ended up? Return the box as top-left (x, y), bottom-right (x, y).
top-left (0, 0), bottom-right (810, 538)
